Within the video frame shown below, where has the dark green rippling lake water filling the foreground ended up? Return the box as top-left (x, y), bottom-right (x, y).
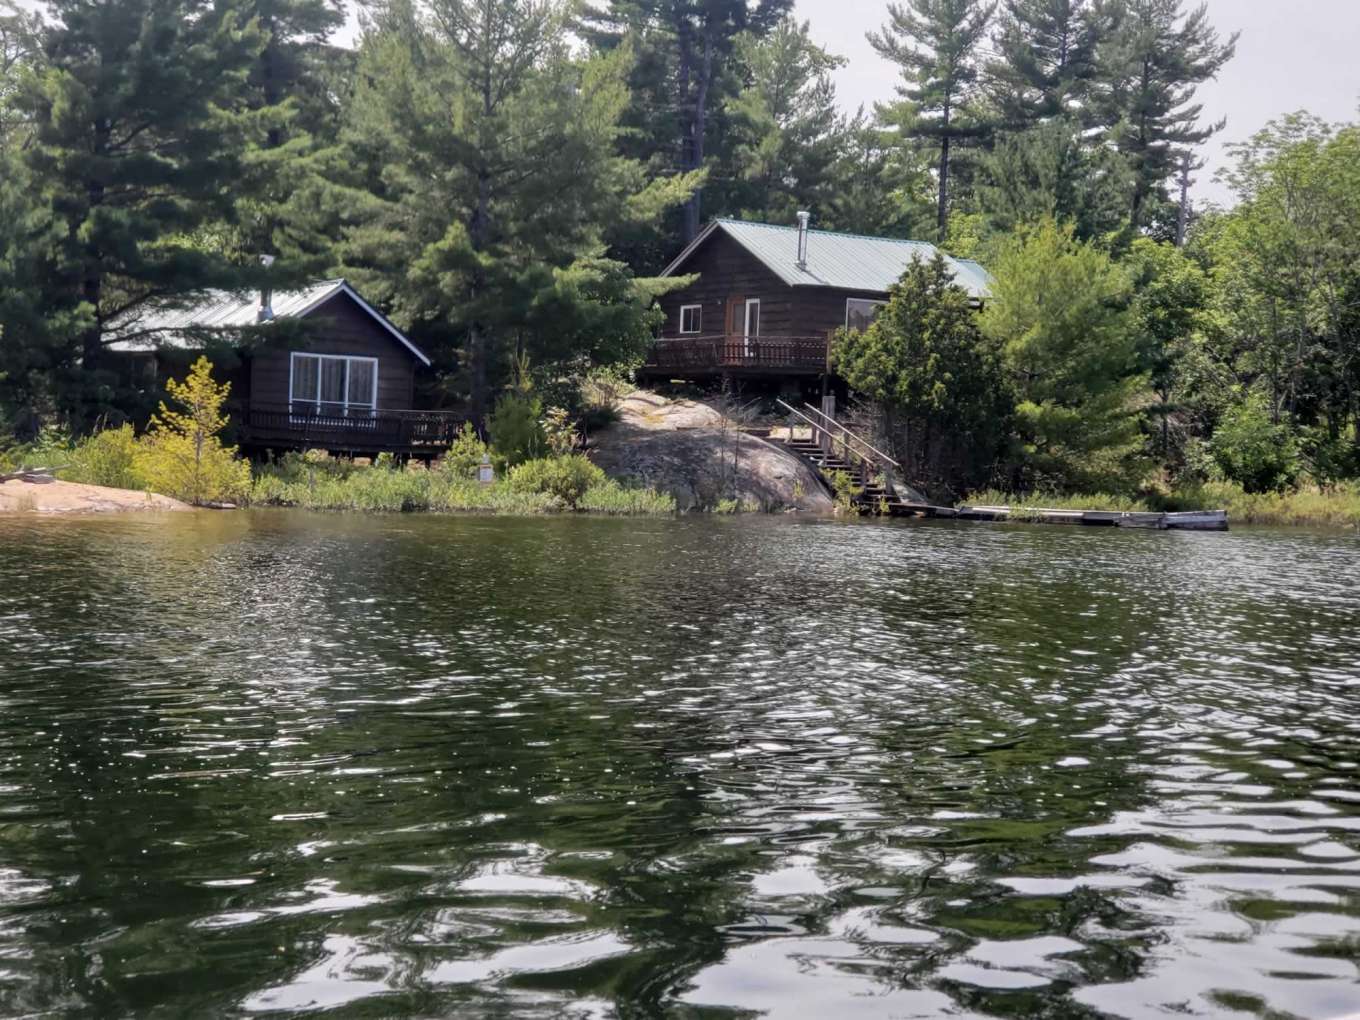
top-left (0, 511), bottom-right (1360, 1020)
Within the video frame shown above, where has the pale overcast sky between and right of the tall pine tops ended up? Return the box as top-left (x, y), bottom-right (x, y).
top-left (796, 0), bottom-right (1360, 201)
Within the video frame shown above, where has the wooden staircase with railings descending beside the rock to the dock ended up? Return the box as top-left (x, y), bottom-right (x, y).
top-left (772, 400), bottom-right (934, 517)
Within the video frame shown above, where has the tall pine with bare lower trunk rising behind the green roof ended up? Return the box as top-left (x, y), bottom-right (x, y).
top-left (868, 0), bottom-right (997, 239)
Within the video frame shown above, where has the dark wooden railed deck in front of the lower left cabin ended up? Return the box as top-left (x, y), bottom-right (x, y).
top-left (237, 404), bottom-right (465, 460)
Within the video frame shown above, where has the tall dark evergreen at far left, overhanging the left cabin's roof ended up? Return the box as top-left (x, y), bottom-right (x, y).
top-left (23, 0), bottom-right (270, 424)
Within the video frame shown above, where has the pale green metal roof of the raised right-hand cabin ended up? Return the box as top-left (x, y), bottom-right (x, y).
top-left (662, 219), bottom-right (991, 301)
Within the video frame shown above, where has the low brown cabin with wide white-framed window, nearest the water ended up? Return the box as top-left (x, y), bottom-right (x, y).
top-left (109, 280), bottom-right (462, 460)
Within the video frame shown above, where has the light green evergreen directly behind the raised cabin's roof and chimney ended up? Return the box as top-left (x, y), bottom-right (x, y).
top-left (719, 18), bottom-right (845, 223)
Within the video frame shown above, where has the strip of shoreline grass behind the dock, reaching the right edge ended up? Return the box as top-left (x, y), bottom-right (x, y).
top-left (964, 481), bottom-right (1360, 528)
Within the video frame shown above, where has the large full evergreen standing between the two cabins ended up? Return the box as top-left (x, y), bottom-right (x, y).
top-left (340, 0), bottom-right (694, 423)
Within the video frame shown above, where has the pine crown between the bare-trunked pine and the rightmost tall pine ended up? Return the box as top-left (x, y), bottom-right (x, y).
top-left (987, 0), bottom-right (1108, 131)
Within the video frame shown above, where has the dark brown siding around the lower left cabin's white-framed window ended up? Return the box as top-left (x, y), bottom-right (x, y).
top-left (250, 294), bottom-right (419, 411)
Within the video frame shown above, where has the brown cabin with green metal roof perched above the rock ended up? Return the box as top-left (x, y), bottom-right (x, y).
top-left (642, 214), bottom-right (989, 388)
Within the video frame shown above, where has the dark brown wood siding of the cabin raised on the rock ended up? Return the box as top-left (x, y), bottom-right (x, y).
top-left (658, 230), bottom-right (887, 337)
